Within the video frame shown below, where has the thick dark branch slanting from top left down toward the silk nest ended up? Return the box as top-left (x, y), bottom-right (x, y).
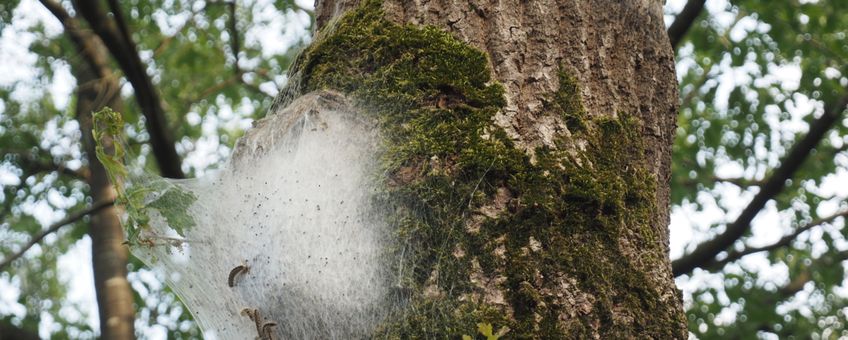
top-left (74, 0), bottom-right (185, 178)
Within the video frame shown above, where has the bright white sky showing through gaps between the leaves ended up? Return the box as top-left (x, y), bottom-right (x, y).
top-left (0, 0), bottom-right (848, 339)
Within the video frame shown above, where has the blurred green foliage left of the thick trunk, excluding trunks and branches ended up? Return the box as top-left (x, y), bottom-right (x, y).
top-left (0, 0), bottom-right (310, 339)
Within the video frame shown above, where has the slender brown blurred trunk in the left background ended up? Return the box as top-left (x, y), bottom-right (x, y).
top-left (72, 39), bottom-right (135, 340)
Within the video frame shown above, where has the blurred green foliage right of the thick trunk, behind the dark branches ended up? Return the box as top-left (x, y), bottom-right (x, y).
top-left (672, 0), bottom-right (848, 339)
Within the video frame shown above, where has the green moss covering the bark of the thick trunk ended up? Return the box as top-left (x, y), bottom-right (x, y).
top-left (294, 1), bottom-right (678, 338)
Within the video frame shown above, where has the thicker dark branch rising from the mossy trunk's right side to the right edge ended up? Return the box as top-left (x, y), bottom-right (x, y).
top-left (671, 95), bottom-right (848, 277)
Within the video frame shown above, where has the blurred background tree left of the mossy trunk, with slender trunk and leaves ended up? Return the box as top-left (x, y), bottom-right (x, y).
top-left (0, 0), bottom-right (309, 339)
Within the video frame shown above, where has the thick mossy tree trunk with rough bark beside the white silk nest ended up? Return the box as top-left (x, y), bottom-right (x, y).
top-left (272, 0), bottom-right (686, 339)
